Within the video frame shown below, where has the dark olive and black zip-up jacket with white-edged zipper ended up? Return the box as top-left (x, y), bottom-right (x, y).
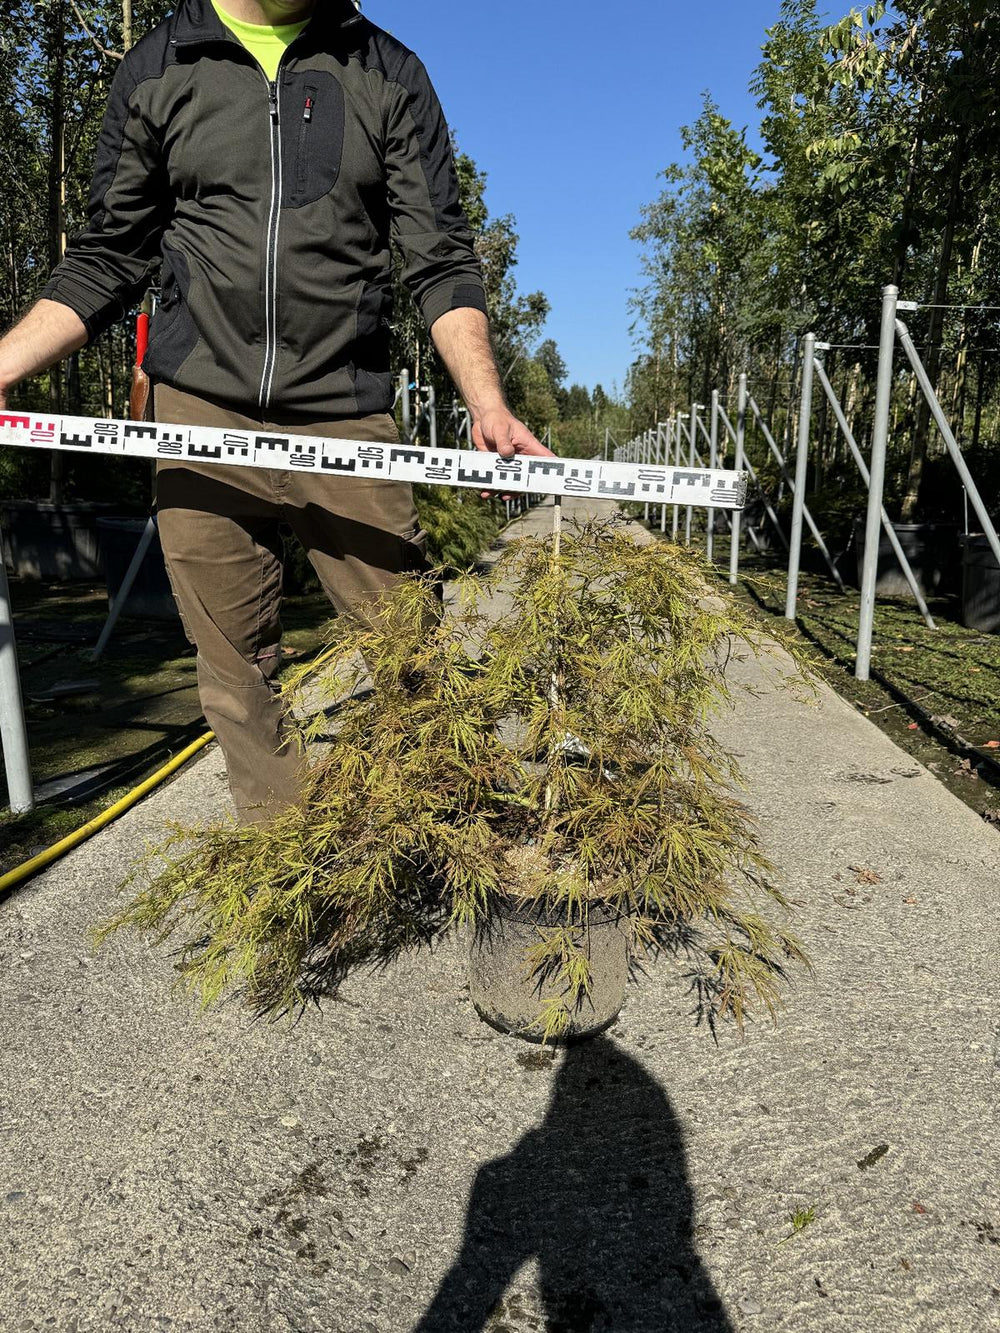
top-left (43, 0), bottom-right (485, 421)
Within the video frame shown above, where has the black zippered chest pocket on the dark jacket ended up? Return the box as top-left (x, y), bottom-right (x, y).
top-left (281, 71), bottom-right (344, 208)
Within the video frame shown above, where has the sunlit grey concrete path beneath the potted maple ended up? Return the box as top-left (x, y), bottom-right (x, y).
top-left (0, 508), bottom-right (1000, 1333)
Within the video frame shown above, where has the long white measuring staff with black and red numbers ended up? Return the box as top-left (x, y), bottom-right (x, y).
top-left (0, 412), bottom-right (747, 509)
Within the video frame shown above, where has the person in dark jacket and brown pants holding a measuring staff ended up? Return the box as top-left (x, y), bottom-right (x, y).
top-left (0, 0), bottom-right (549, 821)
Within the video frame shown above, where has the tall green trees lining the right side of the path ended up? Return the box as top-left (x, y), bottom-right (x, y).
top-left (627, 0), bottom-right (1000, 519)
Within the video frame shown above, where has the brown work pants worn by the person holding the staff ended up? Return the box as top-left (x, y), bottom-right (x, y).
top-left (153, 384), bottom-right (427, 821)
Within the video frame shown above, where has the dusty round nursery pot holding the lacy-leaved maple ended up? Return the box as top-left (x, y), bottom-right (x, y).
top-left (469, 898), bottom-right (629, 1042)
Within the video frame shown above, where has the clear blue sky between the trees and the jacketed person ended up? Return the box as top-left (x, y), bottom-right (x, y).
top-left (373, 0), bottom-right (805, 388)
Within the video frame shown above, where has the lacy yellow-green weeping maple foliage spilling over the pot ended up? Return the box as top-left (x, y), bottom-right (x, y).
top-left (101, 523), bottom-right (807, 1036)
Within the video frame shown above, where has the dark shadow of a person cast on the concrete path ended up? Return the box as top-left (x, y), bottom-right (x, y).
top-left (413, 1037), bottom-right (732, 1333)
